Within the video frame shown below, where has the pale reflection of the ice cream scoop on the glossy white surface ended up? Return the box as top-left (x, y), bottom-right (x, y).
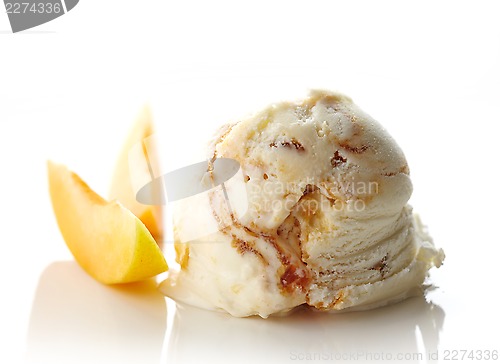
top-left (167, 297), bottom-right (444, 364)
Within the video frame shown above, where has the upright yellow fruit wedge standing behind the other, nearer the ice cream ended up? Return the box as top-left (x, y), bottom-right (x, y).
top-left (109, 107), bottom-right (163, 242)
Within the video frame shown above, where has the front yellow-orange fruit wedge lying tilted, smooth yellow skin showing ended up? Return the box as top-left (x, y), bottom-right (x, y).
top-left (48, 162), bottom-right (168, 284)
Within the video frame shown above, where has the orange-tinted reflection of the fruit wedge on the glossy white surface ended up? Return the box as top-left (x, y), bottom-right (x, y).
top-left (27, 262), bottom-right (167, 364)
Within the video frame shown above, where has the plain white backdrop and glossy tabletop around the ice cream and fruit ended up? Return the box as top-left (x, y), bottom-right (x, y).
top-left (0, 0), bottom-right (500, 363)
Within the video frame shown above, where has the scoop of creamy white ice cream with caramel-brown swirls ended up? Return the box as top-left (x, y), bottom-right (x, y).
top-left (160, 90), bottom-right (444, 317)
